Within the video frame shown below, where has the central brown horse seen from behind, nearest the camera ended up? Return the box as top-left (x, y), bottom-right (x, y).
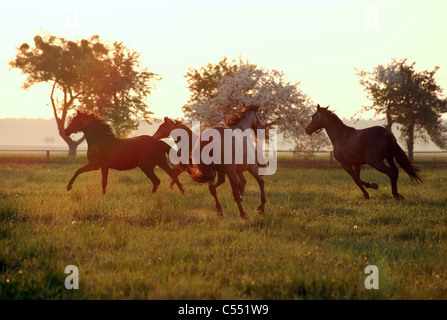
top-left (191, 104), bottom-right (266, 219)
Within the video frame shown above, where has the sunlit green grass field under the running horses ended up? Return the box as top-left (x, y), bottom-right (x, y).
top-left (0, 163), bottom-right (447, 299)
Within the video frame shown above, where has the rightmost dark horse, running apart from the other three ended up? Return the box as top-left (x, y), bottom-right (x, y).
top-left (305, 105), bottom-right (423, 200)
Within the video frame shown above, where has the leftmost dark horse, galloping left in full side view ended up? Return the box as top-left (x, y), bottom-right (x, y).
top-left (64, 111), bottom-right (184, 194)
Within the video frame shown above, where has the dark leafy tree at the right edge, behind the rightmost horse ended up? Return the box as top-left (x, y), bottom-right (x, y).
top-left (357, 59), bottom-right (447, 160)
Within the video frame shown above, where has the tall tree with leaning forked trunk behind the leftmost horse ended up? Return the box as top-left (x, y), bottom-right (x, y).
top-left (9, 35), bottom-right (161, 156)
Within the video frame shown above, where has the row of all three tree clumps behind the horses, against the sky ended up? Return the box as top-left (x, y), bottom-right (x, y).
top-left (9, 34), bottom-right (447, 159)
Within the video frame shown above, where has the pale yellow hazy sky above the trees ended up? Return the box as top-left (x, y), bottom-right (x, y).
top-left (0, 0), bottom-right (447, 118)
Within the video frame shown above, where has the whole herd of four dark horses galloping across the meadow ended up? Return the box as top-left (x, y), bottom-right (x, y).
top-left (65, 104), bottom-right (422, 218)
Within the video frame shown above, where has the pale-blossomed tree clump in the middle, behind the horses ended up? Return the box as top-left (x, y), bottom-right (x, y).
top-left (182, 58), bottom-right (327, 150)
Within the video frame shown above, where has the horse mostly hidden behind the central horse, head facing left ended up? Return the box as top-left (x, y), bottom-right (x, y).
top-left (153, 117), bottom-right (247, 192)
